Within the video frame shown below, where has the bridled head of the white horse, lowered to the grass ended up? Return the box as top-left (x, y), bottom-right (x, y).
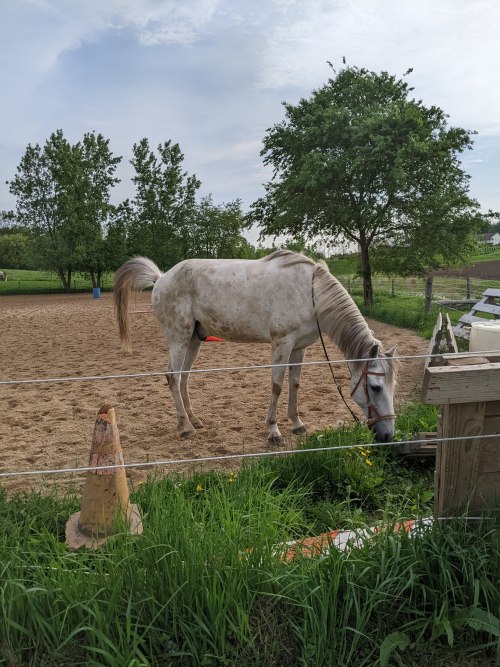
top-left (349, 343), bottom-right (396, 442)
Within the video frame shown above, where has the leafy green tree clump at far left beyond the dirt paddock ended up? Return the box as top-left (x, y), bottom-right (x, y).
top-left (9, 130), bottom-right (121, 289)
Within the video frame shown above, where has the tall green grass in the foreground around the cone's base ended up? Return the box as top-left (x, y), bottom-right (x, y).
top-left (0, 405), bottom-right (500, 667)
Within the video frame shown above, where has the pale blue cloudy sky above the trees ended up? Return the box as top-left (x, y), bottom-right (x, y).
top-left (0, 0), bottom-right (500, 242)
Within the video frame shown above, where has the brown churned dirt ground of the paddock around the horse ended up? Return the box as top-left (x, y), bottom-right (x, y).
top-left (0, 293), bottom-right (428, 490)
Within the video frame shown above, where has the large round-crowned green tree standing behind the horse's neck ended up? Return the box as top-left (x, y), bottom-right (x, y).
top-left (251, 64), bottom-right (478, 305)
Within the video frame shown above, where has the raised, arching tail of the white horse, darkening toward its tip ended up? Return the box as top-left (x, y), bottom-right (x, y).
top-left (113, 257), bottom-right (163, 352)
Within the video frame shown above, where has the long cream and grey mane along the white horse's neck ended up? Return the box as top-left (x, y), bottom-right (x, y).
top-left (261, 250), bottom-right (396, 381)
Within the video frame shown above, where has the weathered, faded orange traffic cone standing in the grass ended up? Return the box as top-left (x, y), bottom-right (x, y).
top-left (66, 405), bottom-right (142, 549)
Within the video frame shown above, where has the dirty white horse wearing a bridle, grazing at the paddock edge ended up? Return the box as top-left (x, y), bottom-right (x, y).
top-left (114, 250), bottom-right (396, 443)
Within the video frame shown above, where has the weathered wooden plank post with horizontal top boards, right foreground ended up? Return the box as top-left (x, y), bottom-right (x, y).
top-left (422, 352), bottom-right (500, 517)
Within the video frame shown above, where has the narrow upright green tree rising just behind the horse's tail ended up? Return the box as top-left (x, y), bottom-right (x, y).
top-left (129, 138), bottom-right (201, 269)
